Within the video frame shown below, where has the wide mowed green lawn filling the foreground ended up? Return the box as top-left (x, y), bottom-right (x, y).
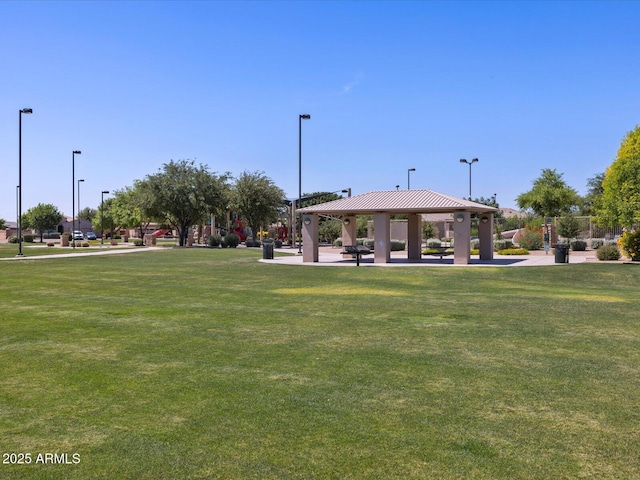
top-left (0, 249), bottom-right (640, 479)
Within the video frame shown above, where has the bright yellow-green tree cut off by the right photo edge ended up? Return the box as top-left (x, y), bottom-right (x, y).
top-left (596, 126), bottom-right (640, 228)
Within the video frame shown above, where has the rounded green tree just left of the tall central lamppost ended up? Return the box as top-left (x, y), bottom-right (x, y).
top-left (232, 171), bottom-right (284, 237)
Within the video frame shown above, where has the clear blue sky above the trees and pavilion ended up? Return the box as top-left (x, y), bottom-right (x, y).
top-left (0, 1), bottom-right (640, 220)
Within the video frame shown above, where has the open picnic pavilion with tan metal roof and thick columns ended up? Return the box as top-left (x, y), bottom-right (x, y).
top-left (298, 190), bottom-right (498, 265)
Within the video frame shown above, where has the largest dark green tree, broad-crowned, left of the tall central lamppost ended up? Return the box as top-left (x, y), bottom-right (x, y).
top-left (140, 160), bottom-right (229, 246)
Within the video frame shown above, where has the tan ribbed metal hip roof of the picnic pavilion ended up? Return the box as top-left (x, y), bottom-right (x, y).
top-left (298, 190), bottom-right (497, 215)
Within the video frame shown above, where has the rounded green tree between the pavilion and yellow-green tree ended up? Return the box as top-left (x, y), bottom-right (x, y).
top-left (516, 168), bottom-right (580, 217)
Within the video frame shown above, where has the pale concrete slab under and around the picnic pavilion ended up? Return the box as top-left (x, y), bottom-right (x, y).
top-left (260, 247), bottom-right (597, 267)
